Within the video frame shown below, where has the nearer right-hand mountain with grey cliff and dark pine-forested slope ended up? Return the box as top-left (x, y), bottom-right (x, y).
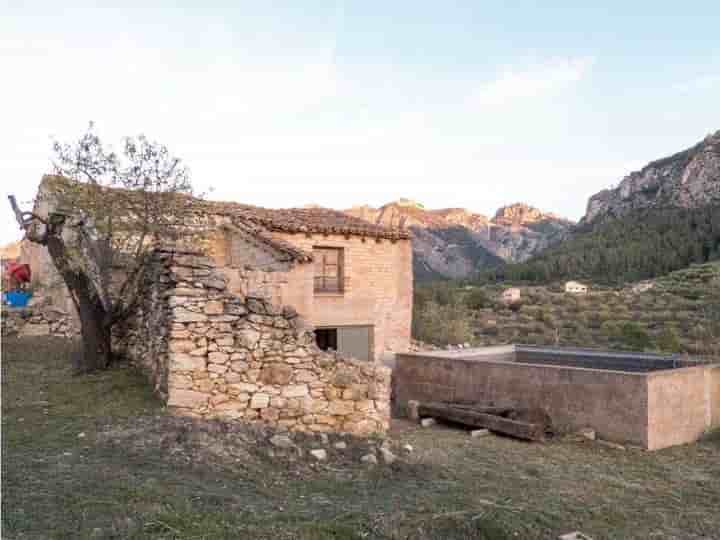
top-left (481, 132), bottom-right (720, 284)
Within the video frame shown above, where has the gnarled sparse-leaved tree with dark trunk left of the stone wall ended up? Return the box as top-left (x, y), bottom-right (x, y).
top-left (10, 123), bottom-right (200, 372)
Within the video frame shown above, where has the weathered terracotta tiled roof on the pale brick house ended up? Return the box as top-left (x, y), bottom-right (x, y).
top-left (200, 201), bottom-right (410, 240)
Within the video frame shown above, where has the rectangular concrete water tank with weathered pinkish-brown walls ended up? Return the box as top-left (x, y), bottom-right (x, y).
top-left (393, 346), bottom-right (720, 450)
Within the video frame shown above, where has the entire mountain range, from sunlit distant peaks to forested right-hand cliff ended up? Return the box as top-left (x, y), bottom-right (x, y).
top-left (345, 131), bottom-right (720, 281)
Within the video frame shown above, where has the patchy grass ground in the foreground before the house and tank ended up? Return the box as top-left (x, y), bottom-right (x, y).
top-left (2, 338), bottom-right (720, 540)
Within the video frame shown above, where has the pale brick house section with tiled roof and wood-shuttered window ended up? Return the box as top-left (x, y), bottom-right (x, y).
top-left (203, 202), bottom-right (413, 360)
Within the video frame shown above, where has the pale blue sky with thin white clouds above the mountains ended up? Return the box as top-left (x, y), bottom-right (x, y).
top-left (0, 0), bottom-right (720, 244)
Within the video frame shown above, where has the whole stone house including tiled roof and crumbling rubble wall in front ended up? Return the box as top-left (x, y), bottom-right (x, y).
top-left (15, 178), bottom-right (413, 434)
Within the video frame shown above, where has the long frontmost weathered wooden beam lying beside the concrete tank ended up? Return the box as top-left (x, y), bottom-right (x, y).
top-left (418, 403), bottom-right (545, 441)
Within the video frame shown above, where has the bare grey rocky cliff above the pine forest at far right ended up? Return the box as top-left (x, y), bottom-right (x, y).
top-left (582, 131), bottom-right (720, 224)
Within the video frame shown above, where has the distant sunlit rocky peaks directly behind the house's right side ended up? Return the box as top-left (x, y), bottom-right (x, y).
top-left (345, 199), bottom-right (573, 281)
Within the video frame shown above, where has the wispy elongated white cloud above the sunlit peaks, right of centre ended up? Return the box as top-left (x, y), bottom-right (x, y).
top-left (472, 58), bottom-right (593, 106)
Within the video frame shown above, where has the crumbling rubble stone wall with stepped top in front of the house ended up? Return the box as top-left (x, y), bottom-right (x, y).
top-left (119, 251), bottom-right (390, 434)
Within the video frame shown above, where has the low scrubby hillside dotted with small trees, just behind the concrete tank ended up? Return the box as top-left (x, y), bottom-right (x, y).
top-left (413, 263), bottom-right (720, 355)
